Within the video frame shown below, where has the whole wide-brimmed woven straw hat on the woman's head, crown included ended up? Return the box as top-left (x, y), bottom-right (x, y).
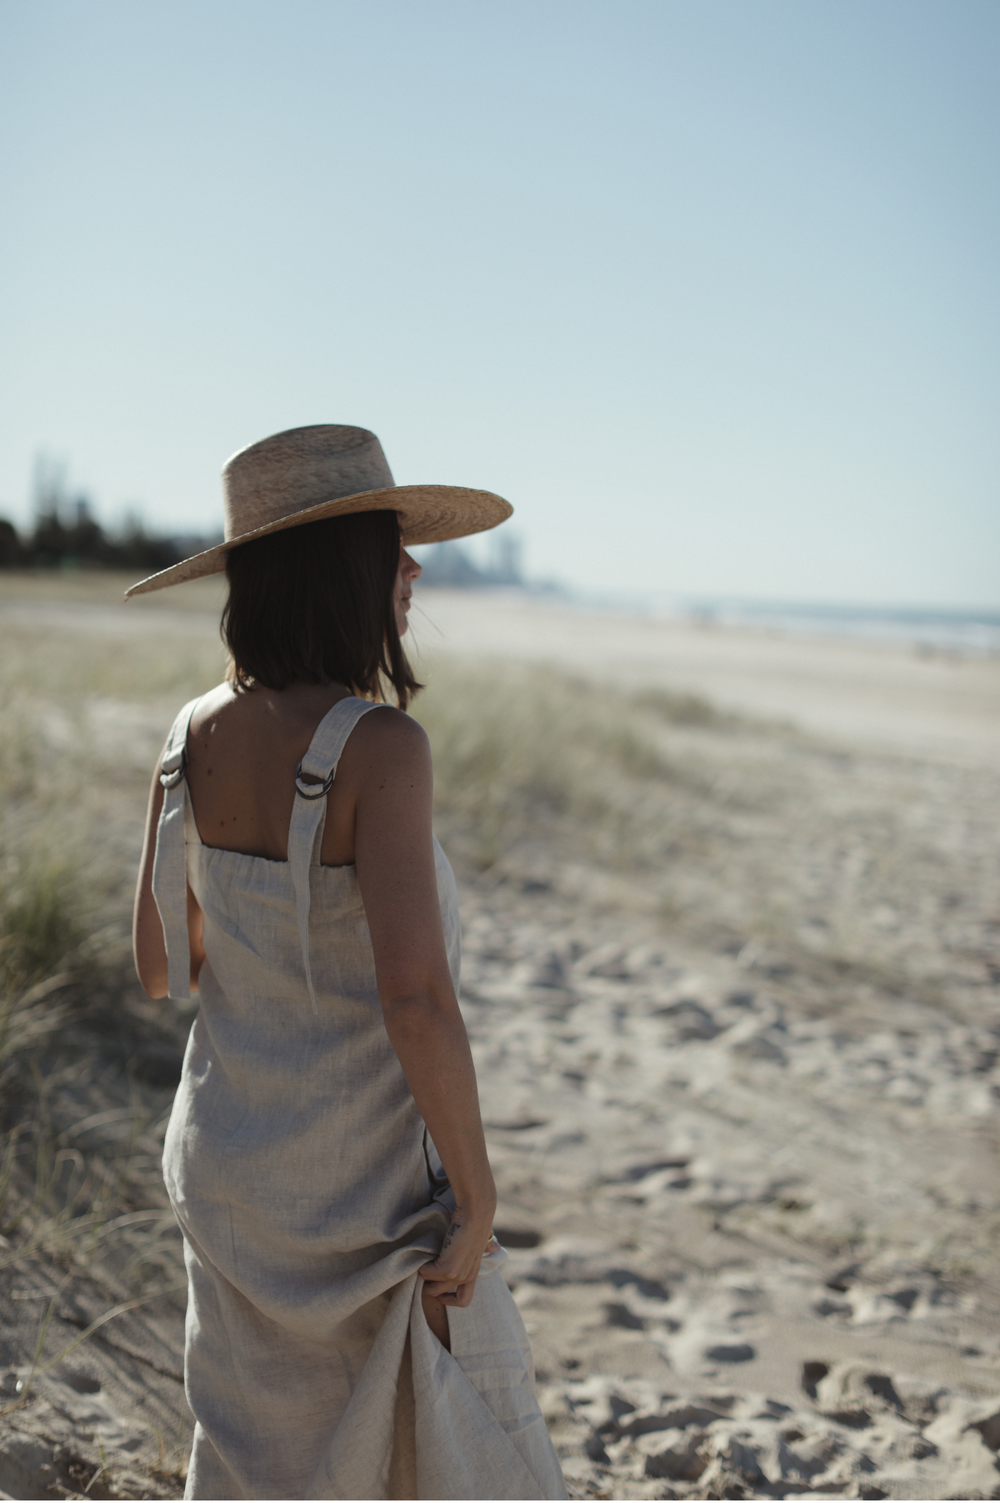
top-left (125, 422), bottom-right (514, 600)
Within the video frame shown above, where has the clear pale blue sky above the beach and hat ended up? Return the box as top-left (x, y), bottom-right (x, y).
top-left (0, 0), bottom-right (1000, 606)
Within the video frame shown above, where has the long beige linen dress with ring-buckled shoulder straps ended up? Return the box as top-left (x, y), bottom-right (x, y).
top-left (153, 697), bottom-right (567, 1498)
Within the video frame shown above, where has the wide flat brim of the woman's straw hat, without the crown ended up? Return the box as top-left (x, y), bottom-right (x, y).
top-left (125, 485), bottom-right (514, 600)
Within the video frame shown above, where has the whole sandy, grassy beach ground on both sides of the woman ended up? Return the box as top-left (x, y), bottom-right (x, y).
top-left (0, 573), bottom-right (1000, 1498)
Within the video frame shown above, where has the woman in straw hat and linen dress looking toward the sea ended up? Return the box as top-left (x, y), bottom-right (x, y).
top-left (129, 427), bottom-right (565, 1498)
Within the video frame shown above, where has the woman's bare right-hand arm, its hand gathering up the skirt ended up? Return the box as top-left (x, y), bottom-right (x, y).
top-left (348, 709), bottom-right (496, 1306)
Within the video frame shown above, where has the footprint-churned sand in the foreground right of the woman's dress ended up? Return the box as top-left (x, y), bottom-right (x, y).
top-left (465, 876), bottom-right (1000, 1498)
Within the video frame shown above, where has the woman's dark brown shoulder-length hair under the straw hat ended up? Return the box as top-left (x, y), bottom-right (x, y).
top-left (223, 511), bottom-right (421, 709)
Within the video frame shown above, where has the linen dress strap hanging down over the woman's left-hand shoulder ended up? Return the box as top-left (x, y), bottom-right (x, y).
top-left (153, 696), bottom-right (200, 1001)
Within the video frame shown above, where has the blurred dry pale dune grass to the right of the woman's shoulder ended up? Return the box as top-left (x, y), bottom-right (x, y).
top-left (415, 663), bottom-right (1000, 1013)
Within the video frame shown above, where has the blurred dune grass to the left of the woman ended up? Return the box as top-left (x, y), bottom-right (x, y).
top-left (0, 598), bottom-right (224, 1316)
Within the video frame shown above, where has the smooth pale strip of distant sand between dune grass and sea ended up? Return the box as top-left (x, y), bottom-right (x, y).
top-left (414, 586), bottom-right (1000, 764)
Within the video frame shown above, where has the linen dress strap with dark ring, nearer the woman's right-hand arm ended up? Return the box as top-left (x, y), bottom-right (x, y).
top-left (287, 696), bottom-right (380, 1012)
